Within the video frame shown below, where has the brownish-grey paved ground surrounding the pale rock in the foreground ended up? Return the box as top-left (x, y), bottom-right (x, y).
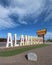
top-left (0, 45), bottom-right (52, 65)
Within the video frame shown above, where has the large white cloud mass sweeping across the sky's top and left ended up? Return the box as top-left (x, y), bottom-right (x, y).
top-left (0, 0), bottom-right (52, 28)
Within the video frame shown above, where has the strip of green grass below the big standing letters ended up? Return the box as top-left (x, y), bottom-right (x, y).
top-left (0, 44), bottom-right (48, 57)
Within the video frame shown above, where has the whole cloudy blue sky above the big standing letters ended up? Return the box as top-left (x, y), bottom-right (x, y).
top-left (0, 0), bottom-right (52, 38)
